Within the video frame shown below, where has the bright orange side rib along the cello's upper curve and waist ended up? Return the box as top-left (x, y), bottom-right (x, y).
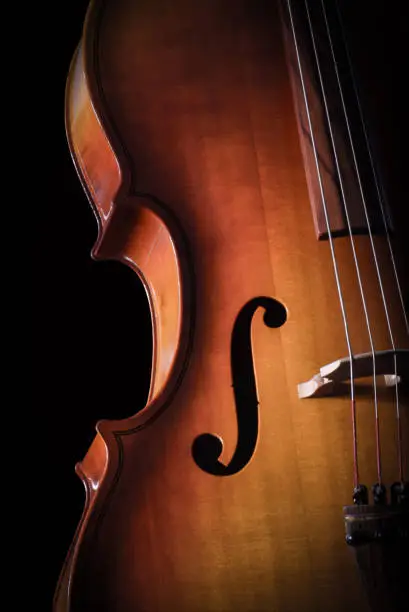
top-left (66, 28), bottom-right (188, 412)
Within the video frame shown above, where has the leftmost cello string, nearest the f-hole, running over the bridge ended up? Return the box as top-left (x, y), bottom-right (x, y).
top-left (287, 0), bottom-right (359, 489)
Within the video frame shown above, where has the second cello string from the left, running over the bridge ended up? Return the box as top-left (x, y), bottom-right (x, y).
top-left (304, 0), bottom-right (382, 482)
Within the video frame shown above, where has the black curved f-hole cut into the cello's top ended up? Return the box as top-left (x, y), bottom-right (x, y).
top-left (192, 297), bottom-right (287, 476)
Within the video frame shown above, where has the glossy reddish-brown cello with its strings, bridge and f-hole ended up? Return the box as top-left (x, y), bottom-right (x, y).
top-left (54, 0), bottom-right (409, 612)
